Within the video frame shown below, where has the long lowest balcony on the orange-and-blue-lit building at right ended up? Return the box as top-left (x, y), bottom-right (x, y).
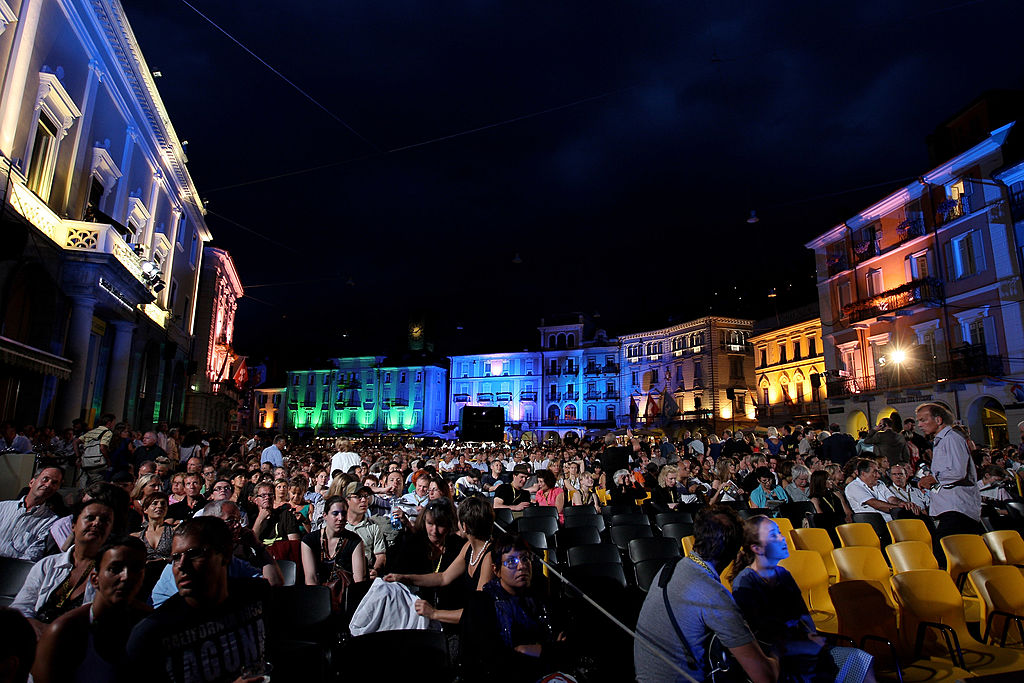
top-left (826, 346), bottom-right (1009, 398)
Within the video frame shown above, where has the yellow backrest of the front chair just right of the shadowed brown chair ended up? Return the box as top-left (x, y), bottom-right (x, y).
top-left (891, 569), bottom-right (977, 647)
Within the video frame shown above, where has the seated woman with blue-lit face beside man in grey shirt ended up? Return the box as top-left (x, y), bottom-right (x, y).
top-left (732, 515), bottom-right (874, 683)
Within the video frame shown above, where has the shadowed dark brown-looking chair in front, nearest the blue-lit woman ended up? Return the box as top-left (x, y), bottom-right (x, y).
top-left (828, 581), bottom-right (971, 683)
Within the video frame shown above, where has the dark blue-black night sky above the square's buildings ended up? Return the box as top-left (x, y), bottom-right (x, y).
top-left (122, 0), bottom-right (1024, 368)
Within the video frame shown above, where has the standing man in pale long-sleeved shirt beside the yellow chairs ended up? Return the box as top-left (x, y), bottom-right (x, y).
top-left (918, 403), bottom-right (983, 539)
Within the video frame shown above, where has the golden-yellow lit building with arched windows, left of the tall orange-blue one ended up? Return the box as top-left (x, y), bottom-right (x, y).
top-left (750, 307), bottom-right (828, 428)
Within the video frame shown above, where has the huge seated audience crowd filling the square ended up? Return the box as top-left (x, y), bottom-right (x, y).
top-left (0, 403), bottom-right (1024, 683)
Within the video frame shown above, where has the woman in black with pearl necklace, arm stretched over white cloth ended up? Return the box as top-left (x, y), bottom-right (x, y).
top-left (384, 497), bottom-right (495, 624)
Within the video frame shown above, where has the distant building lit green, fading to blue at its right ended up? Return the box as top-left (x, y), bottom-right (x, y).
top-left (282, 355), bottom-right (447, 433)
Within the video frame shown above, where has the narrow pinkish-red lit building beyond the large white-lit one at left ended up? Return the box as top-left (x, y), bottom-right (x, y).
top-left (185, 247), bottom-right (245, 433)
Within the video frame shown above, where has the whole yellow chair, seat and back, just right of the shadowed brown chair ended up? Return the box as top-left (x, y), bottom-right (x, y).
top-left (892, 569), bottom-right (1024, 675)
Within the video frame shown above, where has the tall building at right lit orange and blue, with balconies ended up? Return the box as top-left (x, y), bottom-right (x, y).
top-left (807, 124), bottom-right (1024, 445)
